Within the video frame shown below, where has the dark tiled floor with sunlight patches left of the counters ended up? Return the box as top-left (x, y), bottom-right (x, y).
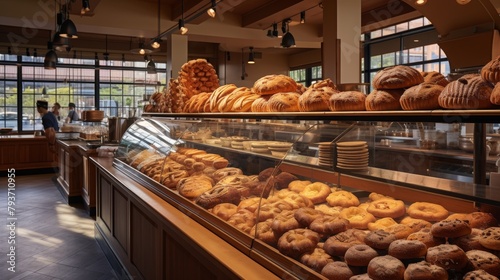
top-left (0, 174), bottom-right (118, 280)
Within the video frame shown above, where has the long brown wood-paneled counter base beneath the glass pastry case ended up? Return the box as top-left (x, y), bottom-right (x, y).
top-left (90, 157), bottom-right (279, 280)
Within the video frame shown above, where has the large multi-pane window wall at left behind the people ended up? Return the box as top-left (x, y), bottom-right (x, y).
top-left (0, 54), bottom-right (166, 131)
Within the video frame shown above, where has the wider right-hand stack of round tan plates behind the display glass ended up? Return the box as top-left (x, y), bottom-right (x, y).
top-left (337, 141), bottom-right (369, 171)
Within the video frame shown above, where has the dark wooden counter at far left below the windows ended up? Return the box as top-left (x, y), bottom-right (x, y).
top-left (0, 135), bottom-right (57, 171)
